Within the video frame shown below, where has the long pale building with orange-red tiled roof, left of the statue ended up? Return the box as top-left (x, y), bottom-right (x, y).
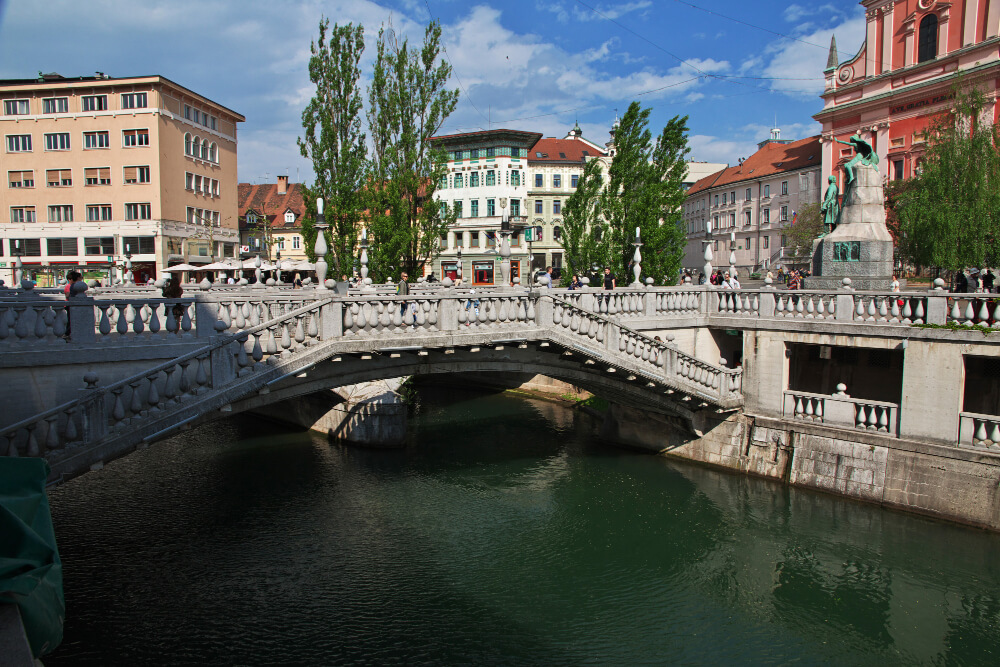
top-left (683, 130), bottom-right (823, 279)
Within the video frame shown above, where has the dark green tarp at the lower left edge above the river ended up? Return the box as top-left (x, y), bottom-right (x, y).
top-left (0, 456), bottom-right (66, 657)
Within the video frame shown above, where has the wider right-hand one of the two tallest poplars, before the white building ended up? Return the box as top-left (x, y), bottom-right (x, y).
top-left (366, 21), bottom-right (458, 281)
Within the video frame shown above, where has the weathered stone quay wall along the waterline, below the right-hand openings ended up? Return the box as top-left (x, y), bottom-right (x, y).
top-left (603, 405), bottom-right (1000, 530)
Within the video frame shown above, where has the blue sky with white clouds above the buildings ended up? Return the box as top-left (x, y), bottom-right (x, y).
top-left (0, 0), bottom-right (864, 183)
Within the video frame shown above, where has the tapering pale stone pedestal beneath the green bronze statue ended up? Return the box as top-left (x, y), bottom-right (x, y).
top-left (806, 164), bottom-right (892, 290)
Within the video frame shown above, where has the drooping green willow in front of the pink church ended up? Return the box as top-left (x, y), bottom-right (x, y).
top-left (887, 85), bottom-right (1000, 270)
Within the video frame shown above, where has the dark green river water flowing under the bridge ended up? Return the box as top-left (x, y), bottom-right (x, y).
top-left (45, 390), bottom-right (1000, 665)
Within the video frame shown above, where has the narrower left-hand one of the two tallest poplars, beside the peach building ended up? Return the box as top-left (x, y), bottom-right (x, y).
top-left (298, 18), bottom-right (367, 277)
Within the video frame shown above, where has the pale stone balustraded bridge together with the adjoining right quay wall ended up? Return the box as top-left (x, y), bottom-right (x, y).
top-left (0, 286), bottom-right (1000, 526)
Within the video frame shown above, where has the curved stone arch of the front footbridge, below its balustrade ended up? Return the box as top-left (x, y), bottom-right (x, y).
top-left (49, 332), bottom-right (738, 481)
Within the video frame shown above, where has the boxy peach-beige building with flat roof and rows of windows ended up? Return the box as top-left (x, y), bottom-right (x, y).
top-left (0, 74), bottom-right (245, 284)
